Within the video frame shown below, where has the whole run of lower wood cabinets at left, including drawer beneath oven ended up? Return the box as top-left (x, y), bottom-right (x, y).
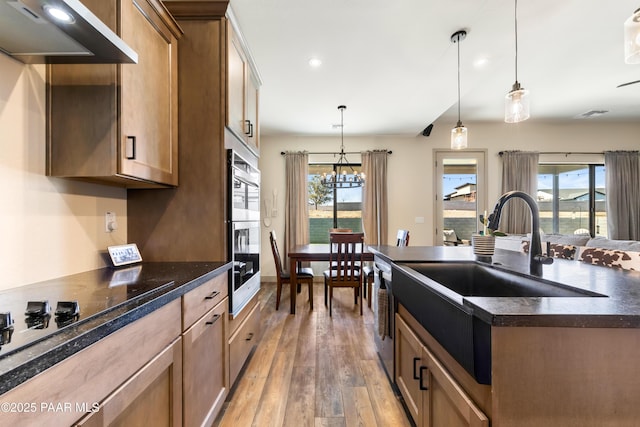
top-left (0, 272), bottom-right (236, 427)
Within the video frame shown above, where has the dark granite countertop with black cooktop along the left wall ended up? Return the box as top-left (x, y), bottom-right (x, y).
top-left (0, 262), bottom-right (231, 394)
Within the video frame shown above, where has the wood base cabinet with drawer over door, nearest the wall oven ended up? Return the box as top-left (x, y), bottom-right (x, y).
top-left (182, 274), bottom-right (229, 426)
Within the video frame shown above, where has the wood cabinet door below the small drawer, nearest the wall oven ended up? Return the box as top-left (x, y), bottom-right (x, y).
top-left (182, 298), bottom-right (229, 426)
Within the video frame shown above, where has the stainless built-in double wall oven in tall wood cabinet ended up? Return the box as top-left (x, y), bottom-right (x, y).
top-left (227, 150), bottom-right (260, 316)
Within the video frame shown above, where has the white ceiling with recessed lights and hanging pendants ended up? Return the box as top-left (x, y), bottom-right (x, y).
top-left (231, 0), bottom-right (640, 135)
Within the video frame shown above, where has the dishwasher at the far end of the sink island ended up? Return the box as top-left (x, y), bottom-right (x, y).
top-left (372, 257), bottom-right (397, 384)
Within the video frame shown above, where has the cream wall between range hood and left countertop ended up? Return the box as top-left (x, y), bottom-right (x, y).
top-left (0, 54), bottom-right (127, 290)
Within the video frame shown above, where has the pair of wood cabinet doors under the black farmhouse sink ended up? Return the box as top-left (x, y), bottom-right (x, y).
top-left (395, 314), bottom-right (489, 427)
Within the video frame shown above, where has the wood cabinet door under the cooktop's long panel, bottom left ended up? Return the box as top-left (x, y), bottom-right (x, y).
top-left (76, 338), bottom-right (182, 427)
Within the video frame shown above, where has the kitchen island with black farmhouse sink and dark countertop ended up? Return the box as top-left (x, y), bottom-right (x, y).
top-left (369, 246), bottom-right (640, 426)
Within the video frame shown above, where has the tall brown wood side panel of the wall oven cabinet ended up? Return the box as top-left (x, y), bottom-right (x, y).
top-left (127, 0), bottom-right (258, 261)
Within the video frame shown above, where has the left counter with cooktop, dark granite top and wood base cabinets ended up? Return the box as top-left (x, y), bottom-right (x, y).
top-left (0, 262), bottom-right (231, 425)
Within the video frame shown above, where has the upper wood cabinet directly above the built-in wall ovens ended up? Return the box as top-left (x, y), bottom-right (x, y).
top-left (226, 13), bottom-right (260, 152)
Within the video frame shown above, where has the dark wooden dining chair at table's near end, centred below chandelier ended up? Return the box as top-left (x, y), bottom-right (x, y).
top-left (324, 233), bottom-right (364, 316)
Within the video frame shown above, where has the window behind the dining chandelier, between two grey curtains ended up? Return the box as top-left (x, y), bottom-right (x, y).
top-left (308, 163), bottom-right (362, 243)
